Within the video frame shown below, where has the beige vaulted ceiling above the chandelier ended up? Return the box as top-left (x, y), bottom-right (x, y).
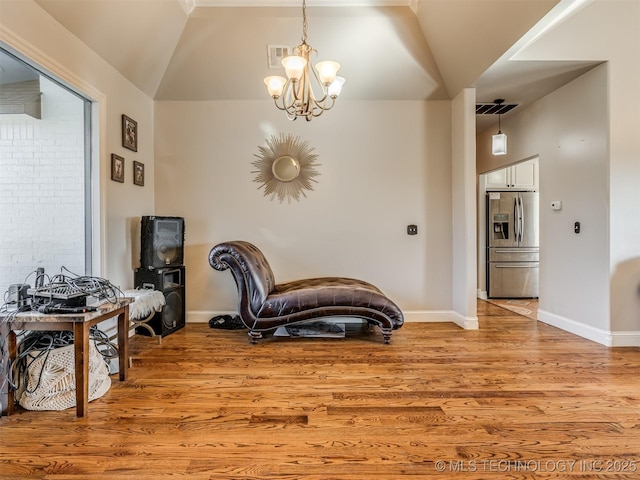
top-left (30, 0), bottom-right (593, 130)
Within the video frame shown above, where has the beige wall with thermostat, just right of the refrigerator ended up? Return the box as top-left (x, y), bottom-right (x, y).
top-left (477, 65), bottom-right (609, 330)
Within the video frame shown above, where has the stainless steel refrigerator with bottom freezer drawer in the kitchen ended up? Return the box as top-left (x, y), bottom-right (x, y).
top-left (487, 192), bottom-right (540, 298)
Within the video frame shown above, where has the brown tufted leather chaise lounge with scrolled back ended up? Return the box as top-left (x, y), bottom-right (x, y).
top-left (209, 241), bottom-right (404, 343)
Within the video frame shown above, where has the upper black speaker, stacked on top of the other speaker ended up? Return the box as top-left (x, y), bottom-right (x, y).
top-left (140, 216), bottom-right (184, 269)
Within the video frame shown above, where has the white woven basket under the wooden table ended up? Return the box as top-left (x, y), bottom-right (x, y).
top-left (18, 342), bottom-right (111, 410)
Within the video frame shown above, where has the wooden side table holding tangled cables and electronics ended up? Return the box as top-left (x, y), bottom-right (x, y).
top-left (0, 298), bottom-right (133, 417)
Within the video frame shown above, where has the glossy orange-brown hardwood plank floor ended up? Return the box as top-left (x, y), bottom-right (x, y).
top-left (0, 301), bottom-right (640, 480)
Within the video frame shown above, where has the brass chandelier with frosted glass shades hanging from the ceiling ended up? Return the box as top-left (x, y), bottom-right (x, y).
top-left (264, 0), bottom-right (345, 121)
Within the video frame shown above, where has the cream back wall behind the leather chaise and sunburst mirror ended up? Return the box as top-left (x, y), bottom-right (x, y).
top-left (155, 101), bottom-right (452, 320)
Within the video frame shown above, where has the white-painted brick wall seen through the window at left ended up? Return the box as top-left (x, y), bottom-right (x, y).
top-left (0, 78), bottom-right (85, 303)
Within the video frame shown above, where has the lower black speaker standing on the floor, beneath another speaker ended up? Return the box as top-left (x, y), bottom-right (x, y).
top-left (134, 267), bottom-right (186, 337)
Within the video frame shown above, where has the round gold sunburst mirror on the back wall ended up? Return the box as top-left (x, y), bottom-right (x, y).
top-left (251, 133), bottom-right (320, 202)
